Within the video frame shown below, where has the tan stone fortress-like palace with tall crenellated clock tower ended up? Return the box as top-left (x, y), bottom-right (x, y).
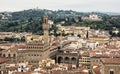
top-left (17, 15), bottom-right (50, 66)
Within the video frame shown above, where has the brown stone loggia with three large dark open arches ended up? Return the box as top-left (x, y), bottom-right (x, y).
top-left (56, 50), bottom-right (79, 68)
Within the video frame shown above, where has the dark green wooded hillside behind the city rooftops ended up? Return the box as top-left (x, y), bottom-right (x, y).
top-left (0, 9), bottom-right (120, 36)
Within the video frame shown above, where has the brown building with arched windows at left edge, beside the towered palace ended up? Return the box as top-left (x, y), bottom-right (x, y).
top-left (0, 43), bottom-right (25, 63)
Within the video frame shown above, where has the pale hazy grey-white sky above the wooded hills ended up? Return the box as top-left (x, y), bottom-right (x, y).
top-left (0, 0), bottom-right (120, 13)
